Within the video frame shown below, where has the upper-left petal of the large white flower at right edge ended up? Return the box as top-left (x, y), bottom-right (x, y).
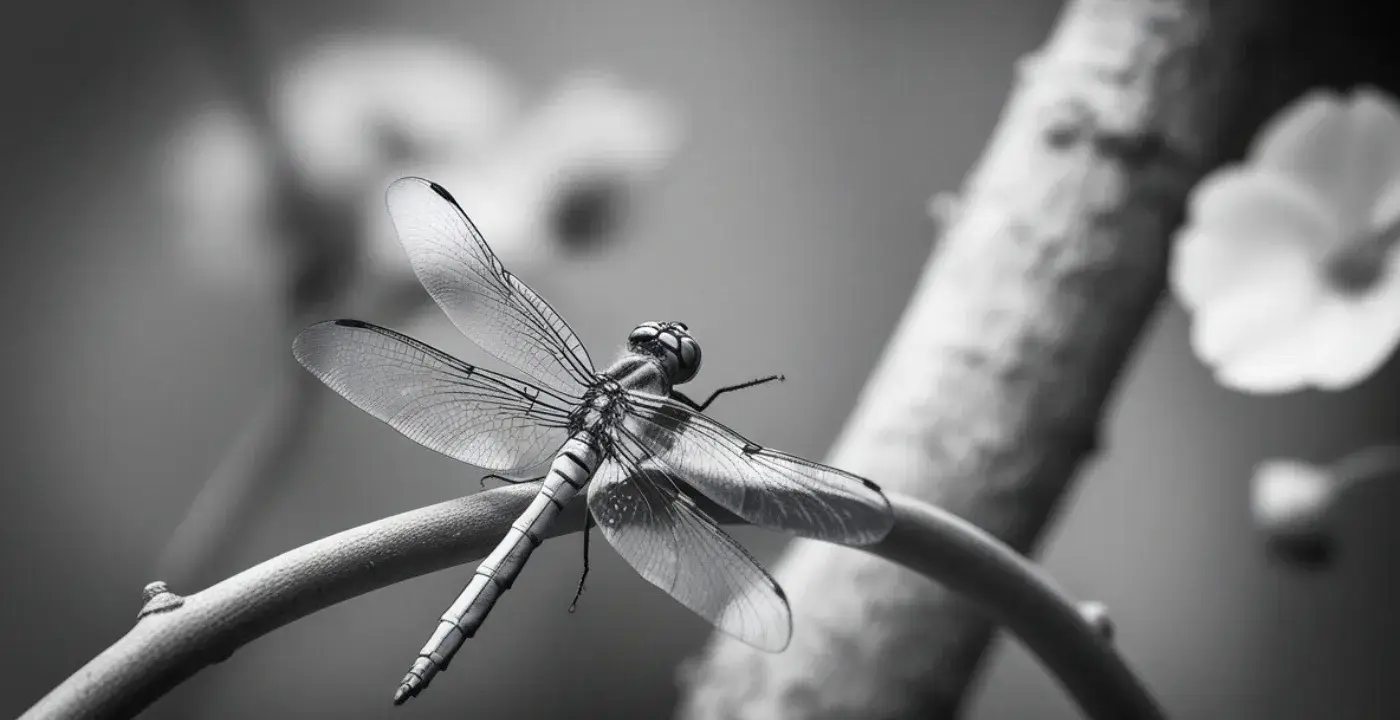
top-left (1170, 167), bottom-right (1336, 310)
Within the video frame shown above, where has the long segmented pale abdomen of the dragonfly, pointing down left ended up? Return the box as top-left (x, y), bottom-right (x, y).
top-left (393, 431), bottom-right (599, 705)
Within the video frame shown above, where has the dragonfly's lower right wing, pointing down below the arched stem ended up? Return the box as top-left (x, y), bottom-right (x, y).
top-left (588, 444), bottom-right (792, 653)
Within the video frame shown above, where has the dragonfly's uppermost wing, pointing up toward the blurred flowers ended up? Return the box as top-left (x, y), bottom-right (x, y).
top-left (386, 178), bottom-right (595, 394)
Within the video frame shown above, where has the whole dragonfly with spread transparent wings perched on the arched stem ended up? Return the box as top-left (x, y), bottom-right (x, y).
top-left (293, 178), bottom-right (893, 705)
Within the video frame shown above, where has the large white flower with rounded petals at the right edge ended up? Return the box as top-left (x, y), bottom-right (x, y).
top-left (1170, 88), bottom-right (1400, 392)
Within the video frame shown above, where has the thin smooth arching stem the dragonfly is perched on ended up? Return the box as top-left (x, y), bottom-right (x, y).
top-left (21, 483), bottom-right (1162, 720)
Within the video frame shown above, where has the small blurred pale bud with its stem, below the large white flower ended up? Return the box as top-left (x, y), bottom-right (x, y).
top-left (1252, 445), bottom-right (1400, 569)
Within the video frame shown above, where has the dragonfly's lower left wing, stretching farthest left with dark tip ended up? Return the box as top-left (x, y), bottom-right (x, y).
top-left (293, 319), bottom-right (577, 472)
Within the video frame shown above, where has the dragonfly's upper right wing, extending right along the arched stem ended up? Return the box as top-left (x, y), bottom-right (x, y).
top-left (619, 392), bottom-right (895, 545)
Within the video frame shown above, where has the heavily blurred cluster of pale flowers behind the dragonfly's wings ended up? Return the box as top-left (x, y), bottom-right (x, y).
top-left (167, 31), bottom-right (679, 316)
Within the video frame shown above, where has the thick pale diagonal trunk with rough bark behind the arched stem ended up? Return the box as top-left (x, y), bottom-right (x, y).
top-left (682, 0), bottom-right (1288, 720)
